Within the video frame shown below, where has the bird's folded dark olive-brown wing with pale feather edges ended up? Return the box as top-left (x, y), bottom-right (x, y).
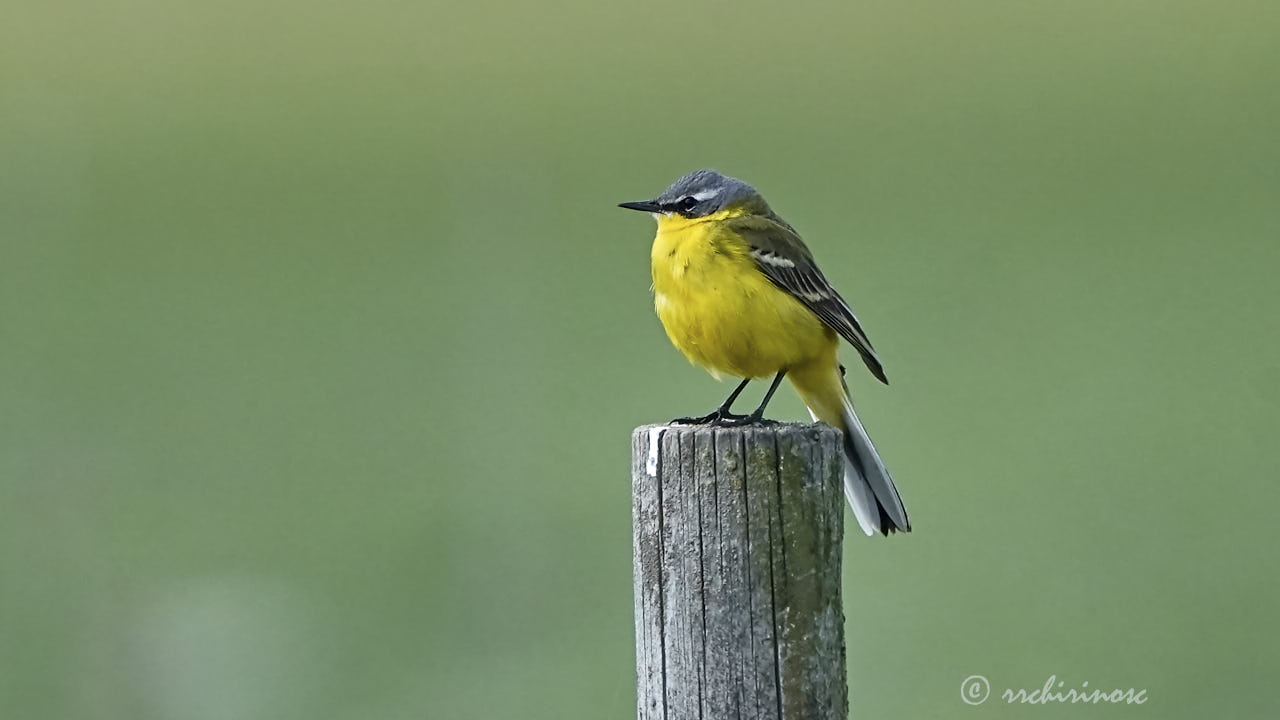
top-left (728, 215), bottom-right (888, 384)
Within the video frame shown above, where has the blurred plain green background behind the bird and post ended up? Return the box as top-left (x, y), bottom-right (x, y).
top-left (0, 0), bottom-right (1280, 720)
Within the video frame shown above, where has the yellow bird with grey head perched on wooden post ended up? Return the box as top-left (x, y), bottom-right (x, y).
top-left (618, 169), bottom-right (911, 536)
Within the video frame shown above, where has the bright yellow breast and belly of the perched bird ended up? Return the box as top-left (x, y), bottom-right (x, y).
top-left (652, 212), bottom-right (836, 378)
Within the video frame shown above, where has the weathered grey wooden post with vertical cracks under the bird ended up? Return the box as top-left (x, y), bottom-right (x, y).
top-left (631, 424), bottom-right (849, 720)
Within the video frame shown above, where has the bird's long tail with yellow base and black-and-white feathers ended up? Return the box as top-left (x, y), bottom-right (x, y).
top-left (787, 357), bottom-right (911, 536)
